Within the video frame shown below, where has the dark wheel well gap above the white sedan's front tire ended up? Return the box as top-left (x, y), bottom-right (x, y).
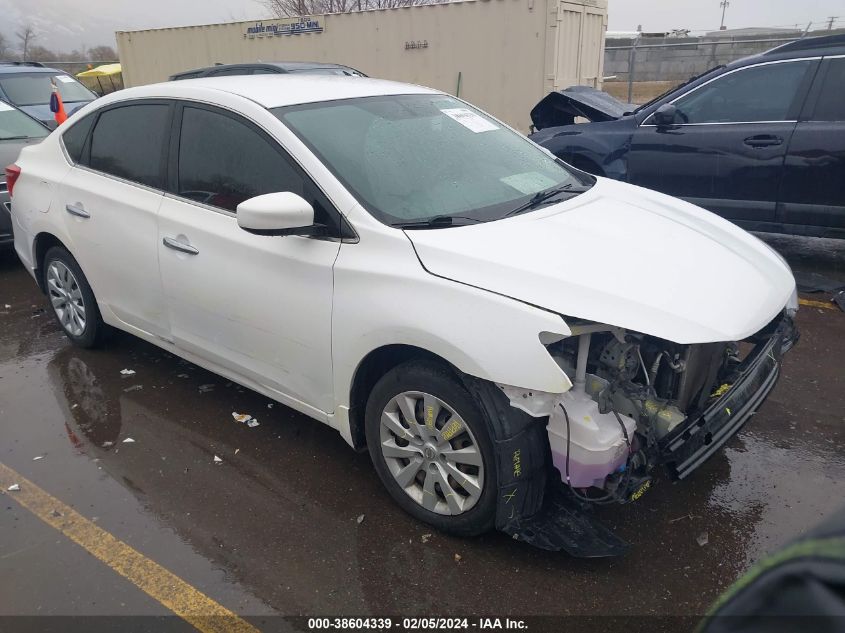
top-left (349, 345), bottom-right (452, 450)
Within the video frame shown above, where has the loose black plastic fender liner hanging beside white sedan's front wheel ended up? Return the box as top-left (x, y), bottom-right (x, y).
top-left (463, 376), bottom-right (628, 558)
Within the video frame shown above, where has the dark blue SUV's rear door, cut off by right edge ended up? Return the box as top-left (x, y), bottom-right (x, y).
top-left (777, 56), bottom-right (845, 237)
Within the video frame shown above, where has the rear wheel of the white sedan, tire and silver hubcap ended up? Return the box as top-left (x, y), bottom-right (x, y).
top-left (42, 246), bottom-right (108, 348)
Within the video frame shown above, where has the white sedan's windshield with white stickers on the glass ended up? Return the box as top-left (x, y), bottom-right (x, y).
top-left (273, 94), bottom-right (586, 225)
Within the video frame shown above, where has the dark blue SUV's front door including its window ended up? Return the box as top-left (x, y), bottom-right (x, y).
top-left (629, 59), bottom-right (818, 224)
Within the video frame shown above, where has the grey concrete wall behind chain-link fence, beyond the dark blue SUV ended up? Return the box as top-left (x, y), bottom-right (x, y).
top-left (604, 31), bottom-right (841, 81)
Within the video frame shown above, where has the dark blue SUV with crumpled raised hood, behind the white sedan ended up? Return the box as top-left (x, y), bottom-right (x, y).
top-left (531, 35), bottom-right (845, 238)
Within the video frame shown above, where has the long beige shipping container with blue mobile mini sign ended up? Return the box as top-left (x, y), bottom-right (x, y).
top-left (117, 0), bottom-right (607, 131)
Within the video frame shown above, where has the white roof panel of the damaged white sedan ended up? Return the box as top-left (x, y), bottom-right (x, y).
top-left (97, 73), bottom-right (439, 108)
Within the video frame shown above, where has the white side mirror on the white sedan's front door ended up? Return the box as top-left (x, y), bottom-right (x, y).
top-left (236, 191), bottom-right (324, 235)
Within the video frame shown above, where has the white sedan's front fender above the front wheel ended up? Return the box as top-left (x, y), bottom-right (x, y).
top-left (332, 234), bottom-right (571, 407)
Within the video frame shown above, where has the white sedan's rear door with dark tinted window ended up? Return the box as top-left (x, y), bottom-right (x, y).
top-left (56, 100), bottom-right (173, 336)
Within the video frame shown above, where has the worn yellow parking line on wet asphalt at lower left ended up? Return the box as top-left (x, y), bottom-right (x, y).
top-left (0, 463), bottom-right (258, 633)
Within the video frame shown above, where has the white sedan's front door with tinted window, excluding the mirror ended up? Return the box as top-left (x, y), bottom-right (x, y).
top-left (158, 105), bottom-right (340, 412)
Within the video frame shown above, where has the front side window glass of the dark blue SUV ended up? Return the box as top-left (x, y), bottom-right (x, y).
top-left (674, 60), bottom-right (815, 123)
